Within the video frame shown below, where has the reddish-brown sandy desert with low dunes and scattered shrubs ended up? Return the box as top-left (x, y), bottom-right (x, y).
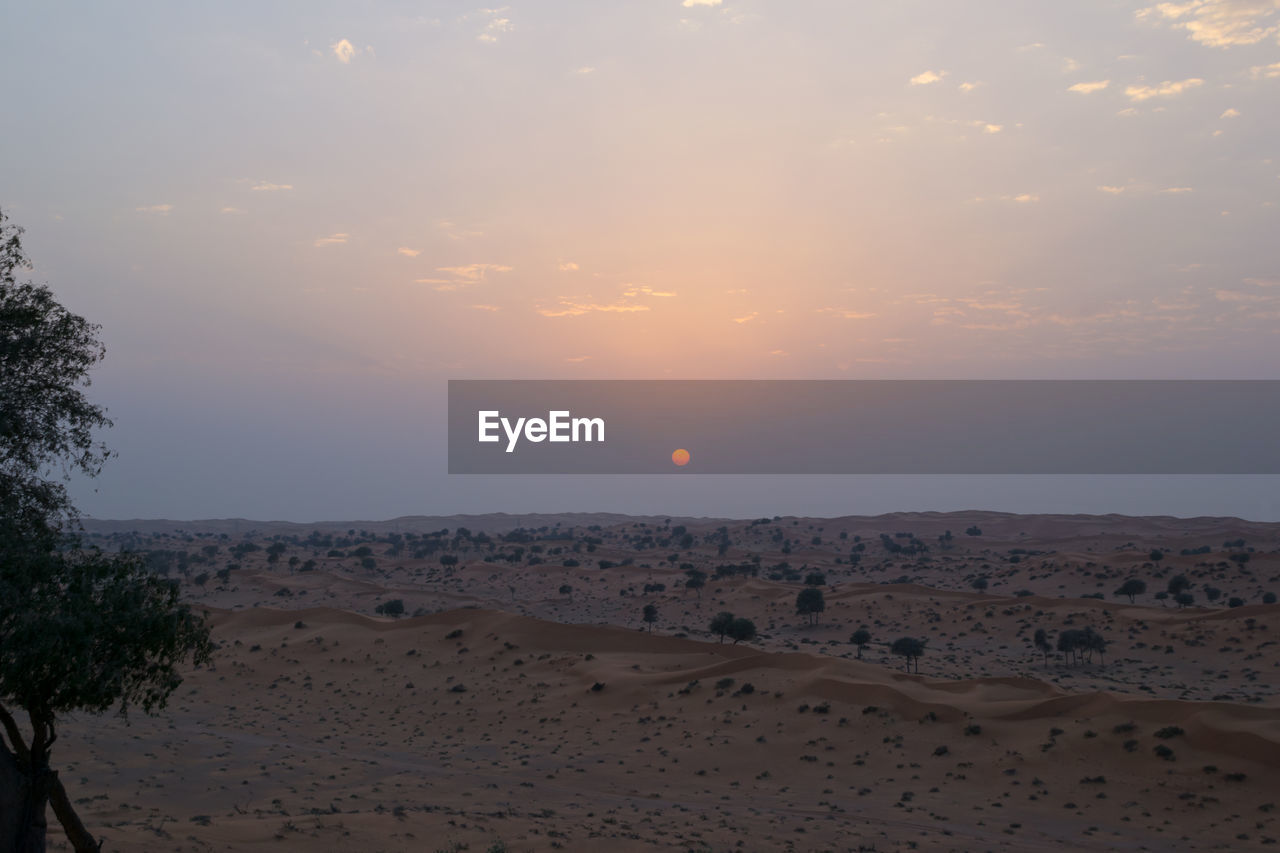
top-left (40, 512), bottom-right (1280, 852)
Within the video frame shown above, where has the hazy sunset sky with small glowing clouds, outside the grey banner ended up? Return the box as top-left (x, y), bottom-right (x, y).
top-left (0, 0), bottom-right (1280, 520)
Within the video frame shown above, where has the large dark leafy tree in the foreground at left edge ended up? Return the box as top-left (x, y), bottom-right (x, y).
top-left (0, 211), bottom-right (212, 853)
